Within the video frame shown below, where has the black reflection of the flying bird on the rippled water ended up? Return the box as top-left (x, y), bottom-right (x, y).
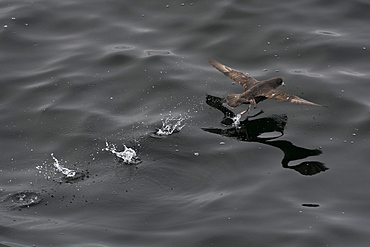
top-left (203, 95), bottom-right (328, 175)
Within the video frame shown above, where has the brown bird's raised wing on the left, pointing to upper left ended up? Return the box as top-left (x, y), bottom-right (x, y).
top-left (208, 58), bottom-right (258, 91)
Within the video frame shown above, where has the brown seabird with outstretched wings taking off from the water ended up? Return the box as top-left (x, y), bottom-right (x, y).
top-left (208, 58), bottom-right (322, 114)
